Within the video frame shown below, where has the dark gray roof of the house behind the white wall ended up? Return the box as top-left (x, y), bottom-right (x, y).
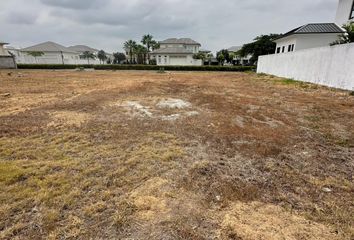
top-left (277, 23), bottom-right (344, 39)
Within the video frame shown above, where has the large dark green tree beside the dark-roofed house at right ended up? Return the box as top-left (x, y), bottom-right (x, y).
top-left (237, 34), bottom-right (281, 63)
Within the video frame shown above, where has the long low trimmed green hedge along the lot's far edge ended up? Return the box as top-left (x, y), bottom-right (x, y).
top-left (17, 64), bottom-right (255, 72)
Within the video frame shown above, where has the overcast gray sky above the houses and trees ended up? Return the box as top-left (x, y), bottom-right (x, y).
top-left (0, 0), bottom-right (338, 52)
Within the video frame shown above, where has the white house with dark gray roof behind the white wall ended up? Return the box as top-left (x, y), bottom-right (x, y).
top-left (274, 23), bottom-right (344, 54)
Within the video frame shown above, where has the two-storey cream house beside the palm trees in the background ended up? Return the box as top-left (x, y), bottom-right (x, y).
top-left (151, 38), bottom-right (203, 66)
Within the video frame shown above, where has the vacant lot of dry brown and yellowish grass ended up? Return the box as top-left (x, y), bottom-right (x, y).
top-left (0, 70), bottom-right (354, 240)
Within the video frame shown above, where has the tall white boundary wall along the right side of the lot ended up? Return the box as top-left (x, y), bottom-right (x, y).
top-left (257, 43), bottom-right (354, 90)
